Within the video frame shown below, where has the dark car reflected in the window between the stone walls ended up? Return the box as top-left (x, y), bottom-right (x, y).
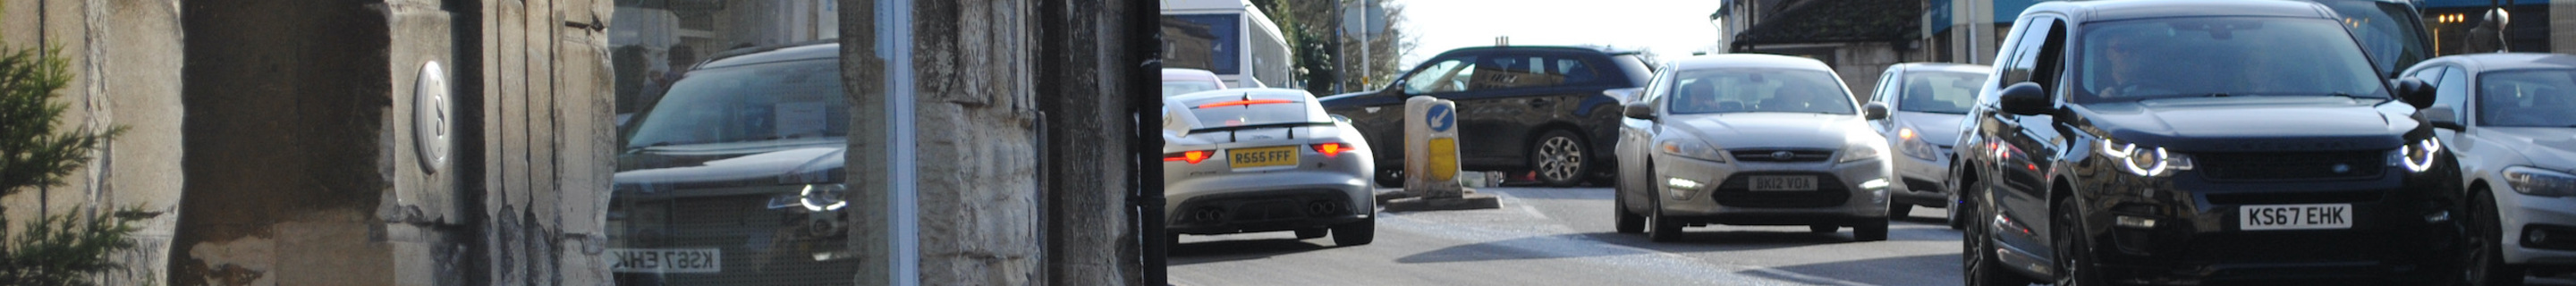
top-left (606, 44), bottom-right (858, 286)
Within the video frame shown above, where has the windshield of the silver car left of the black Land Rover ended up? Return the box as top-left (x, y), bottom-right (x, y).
top-left (1672, 67), bottom-right (1855, 114)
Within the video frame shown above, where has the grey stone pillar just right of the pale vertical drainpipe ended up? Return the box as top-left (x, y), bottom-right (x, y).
top-left (896, 0), bottom-right (1043, 286)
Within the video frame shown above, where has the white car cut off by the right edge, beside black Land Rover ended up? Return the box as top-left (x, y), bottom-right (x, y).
top-left (2403, 55), bottom-right (2576, 286)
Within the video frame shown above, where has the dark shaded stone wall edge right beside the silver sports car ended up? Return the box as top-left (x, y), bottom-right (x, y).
top-left (1030, 0), bottom-right (1159, 286)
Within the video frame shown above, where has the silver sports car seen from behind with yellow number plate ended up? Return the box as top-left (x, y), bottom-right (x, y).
top-left (1162, 88), bottom-right (1378, 245)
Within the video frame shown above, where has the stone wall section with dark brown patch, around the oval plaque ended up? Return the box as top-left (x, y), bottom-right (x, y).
top-left (165, 0), bottom-right (613, 286)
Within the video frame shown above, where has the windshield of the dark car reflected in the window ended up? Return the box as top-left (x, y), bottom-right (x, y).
top-left (626, 59), bottom-right (850, 147)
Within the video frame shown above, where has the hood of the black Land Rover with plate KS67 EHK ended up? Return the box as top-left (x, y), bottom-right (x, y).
top-left (2076, 96), bottom-right (2429, 152)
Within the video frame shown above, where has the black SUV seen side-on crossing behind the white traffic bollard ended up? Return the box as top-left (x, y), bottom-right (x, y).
top-left (1319, 46), bottom-right (1654, 186)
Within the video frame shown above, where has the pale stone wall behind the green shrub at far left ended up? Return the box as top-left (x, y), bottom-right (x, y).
top-left (0, 0), bottom-right (185, 286)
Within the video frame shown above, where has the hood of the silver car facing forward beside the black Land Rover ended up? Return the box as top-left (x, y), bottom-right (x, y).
top-left (1664, 114), bottom-right (1870, 149)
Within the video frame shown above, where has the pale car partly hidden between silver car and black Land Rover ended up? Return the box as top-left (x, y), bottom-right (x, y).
top-left (1868, 62), bottom-right (1994, 230)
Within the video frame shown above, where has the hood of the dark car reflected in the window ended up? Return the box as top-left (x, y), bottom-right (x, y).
top-left (613, 139), bottom-right (848, 188)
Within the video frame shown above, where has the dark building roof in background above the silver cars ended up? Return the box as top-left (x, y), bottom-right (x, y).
top-left (1733, 0), bottom-right (1924, 44)
